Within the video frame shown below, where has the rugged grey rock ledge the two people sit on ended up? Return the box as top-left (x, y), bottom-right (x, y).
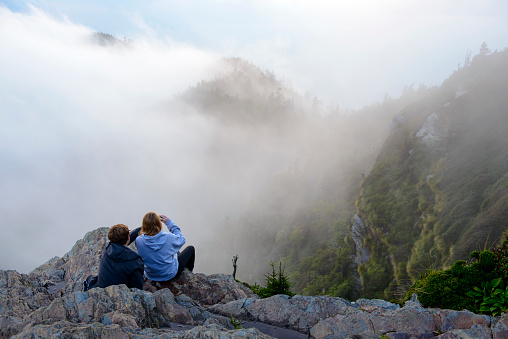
top-left (0, 228), bottom-right (508, 339)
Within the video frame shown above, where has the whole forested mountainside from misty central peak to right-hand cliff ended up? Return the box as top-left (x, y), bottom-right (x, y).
top-left (173, 51), bottom-right (508, 299)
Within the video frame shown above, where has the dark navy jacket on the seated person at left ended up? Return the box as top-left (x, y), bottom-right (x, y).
top-left (94, 228), bottom-right (144, 290)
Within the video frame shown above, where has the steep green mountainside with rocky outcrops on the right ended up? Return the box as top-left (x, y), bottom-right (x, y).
top-left (356, 51), bottom-right (508, 298)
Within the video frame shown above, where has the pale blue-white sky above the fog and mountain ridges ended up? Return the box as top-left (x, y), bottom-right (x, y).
top-left (0, 0), bottom-right (508, 108)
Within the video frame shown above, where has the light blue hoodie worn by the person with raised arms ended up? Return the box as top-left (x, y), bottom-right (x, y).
top-left (136, 219), bottom-right (185, 281)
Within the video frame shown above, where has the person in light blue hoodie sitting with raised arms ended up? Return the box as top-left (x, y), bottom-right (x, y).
top-left (136, 212), bottom-right (196, 282)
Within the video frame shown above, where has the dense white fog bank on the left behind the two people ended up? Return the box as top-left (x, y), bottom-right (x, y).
top-left (0, 7), bottom-right (227, 272)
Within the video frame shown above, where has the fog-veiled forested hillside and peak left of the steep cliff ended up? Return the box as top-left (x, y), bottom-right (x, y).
top-left (175, 59), bottom-right (432, 297)
